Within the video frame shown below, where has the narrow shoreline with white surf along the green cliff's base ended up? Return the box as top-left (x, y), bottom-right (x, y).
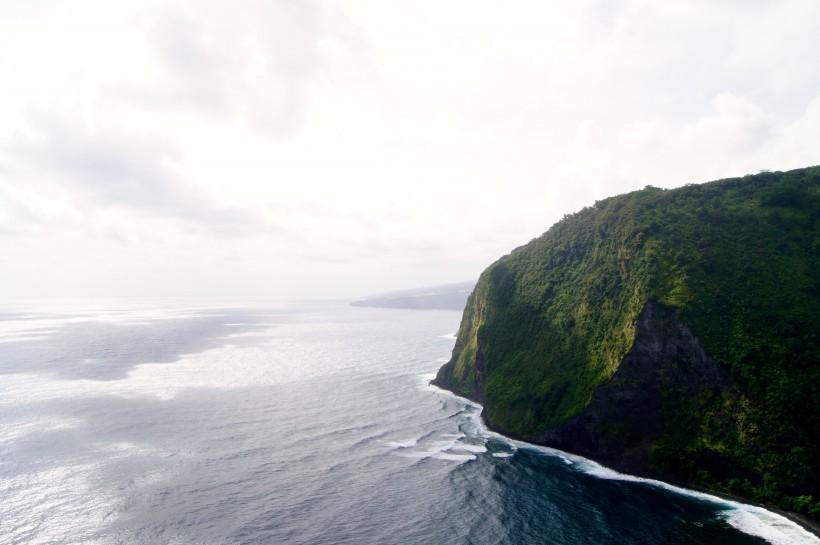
top-left (428, 379), bottom-right (820, 540)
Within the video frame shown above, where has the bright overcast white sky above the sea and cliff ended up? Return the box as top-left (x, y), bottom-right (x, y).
top-left (0, 0), bottom-right (820, 301)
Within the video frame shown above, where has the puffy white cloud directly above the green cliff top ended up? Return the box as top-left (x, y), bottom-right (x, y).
top-left (555, 92), bottom-right (820, 206)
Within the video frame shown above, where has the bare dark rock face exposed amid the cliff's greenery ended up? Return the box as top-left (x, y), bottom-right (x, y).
top-left (527, 301), bottom-right (728, 475)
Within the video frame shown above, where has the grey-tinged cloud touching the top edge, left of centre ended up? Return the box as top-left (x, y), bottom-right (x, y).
top-left (108, 0), bottom-right (363, 138)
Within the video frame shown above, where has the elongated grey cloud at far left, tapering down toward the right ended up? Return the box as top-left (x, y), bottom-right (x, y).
top-left (9, 112), bottom-right (284, 234)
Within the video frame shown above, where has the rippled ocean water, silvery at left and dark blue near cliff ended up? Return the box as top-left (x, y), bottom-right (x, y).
top-left (0, 306), bottom-right (818, 545)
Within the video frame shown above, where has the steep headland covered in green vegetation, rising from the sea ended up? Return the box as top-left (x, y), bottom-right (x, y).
top-left (434, 167), bottom-right (820, 517)
